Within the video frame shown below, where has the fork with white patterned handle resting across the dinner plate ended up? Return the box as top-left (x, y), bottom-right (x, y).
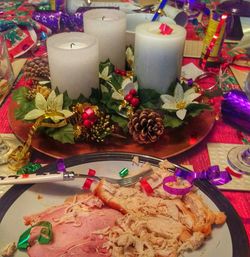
top-left (0, 169), bottom-right (152, 186)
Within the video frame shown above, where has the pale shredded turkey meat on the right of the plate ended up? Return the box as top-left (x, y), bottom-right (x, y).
top-left (94, 161), bottom-right (226, 257)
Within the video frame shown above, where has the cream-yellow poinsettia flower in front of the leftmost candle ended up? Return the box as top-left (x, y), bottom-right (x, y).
top-left (24, 90), bottom-right (73, 123)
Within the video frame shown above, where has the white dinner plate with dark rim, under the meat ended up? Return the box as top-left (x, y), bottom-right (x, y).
top-left (0, 153), bottom-right (248, 257)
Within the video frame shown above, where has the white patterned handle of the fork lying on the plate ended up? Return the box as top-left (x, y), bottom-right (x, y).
top-left (0, 173), bottom-right (65, 185)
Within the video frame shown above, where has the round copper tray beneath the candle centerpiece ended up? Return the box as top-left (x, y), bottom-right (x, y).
top-left (8, 101), bottom-right (215, 158)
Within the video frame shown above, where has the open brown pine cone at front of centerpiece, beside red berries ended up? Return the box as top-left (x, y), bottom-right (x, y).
top-left (128, 109), bottom-right (164, 144)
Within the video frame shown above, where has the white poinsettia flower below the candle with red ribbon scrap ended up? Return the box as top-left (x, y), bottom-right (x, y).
top-left (161, 83), bottom-right (201, 120)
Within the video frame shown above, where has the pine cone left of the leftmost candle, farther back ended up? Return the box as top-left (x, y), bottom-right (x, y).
top-left (24, 56), bottom-right (50, 81)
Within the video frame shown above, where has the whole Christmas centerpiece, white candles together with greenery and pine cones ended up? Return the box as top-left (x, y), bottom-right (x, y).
top-left (7, 17), bottom-right (213, 166)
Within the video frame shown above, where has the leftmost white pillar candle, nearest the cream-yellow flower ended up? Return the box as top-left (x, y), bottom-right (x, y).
top-left (47, 32), bottom-right (99, 98)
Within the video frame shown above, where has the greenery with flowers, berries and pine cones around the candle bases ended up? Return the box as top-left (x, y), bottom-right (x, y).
top-left (11, 48), bottom-right (211, 169)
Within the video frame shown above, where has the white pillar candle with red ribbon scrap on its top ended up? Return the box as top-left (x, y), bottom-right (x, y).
top-left (135, 22), bottom-right (186, 93)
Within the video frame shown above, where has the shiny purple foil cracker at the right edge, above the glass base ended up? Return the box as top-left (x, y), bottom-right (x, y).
top-left (221, 90), bottom-right (250, 132)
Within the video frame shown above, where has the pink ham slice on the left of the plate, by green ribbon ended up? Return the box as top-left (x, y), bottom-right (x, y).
top-left (25, 196), bottom-right (122, 257)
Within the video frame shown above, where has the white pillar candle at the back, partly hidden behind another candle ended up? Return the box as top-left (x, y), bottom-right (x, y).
top-left (83, 8), bottom-right (126, 69)
